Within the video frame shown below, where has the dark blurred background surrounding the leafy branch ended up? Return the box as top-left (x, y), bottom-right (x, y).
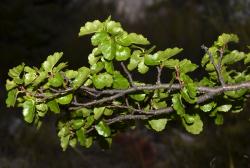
top-left (0, 0), bottom-right (250, 168)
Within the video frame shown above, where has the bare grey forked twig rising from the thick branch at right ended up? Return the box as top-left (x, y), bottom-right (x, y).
top-left (201, 45), bottom-right (225, 86)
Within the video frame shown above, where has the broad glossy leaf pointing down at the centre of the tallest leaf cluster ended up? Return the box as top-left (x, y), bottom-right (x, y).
top-left (99, 38), bottom-right (116, 61)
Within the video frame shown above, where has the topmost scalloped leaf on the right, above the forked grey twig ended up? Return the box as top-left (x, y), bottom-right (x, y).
top-left (214, 33), bottom-right (239, 47)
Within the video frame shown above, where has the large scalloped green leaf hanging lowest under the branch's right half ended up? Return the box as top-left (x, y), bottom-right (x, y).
top-left (182, 114), bottom-right (203, 135)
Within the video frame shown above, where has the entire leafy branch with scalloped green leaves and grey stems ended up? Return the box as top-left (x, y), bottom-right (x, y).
top-left (6, 18), bottom-right (250, 150)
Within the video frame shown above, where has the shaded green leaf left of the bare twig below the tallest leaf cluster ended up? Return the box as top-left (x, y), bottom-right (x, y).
top-left (113, 71), bottom-right (129, 89)
